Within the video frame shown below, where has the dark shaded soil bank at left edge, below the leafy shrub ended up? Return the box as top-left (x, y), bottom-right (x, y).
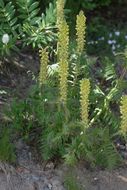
top-left (0, 53), bottom-right (39, 118)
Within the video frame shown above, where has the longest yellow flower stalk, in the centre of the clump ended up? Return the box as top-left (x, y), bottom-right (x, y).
top-left (57, 21), bottom-right (69, 104)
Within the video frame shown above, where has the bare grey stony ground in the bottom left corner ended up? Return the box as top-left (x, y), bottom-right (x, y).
top-left (0, 140), bottom-right (63, 190)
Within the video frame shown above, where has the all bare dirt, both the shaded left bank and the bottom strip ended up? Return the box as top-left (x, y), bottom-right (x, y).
top-left (0, 53), bottom-right (127, 190)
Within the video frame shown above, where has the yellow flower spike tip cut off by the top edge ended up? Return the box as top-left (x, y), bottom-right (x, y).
top-left (56, 0), bottom-right (65, 28)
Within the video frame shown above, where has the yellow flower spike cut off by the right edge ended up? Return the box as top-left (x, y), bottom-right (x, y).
top-left (120, 95), bottom-right (127, 137)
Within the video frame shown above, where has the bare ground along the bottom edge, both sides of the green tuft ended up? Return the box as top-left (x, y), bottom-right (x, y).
top-left (0, 143), bottom-right (127, 190)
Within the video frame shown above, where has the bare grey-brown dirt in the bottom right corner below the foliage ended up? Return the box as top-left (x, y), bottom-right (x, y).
top-left (78, 166), bottom-right (127, 190)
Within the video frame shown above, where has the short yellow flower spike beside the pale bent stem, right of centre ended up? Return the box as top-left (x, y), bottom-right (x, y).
top-left (80, 79), bottom-right (90, 127)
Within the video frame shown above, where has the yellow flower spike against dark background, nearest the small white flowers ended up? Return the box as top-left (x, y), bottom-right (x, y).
top-left (76, 11), bottom-right (86, 54)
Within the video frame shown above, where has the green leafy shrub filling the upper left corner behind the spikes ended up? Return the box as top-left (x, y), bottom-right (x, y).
top-left (0, 0), bottom-right (56, 56)
